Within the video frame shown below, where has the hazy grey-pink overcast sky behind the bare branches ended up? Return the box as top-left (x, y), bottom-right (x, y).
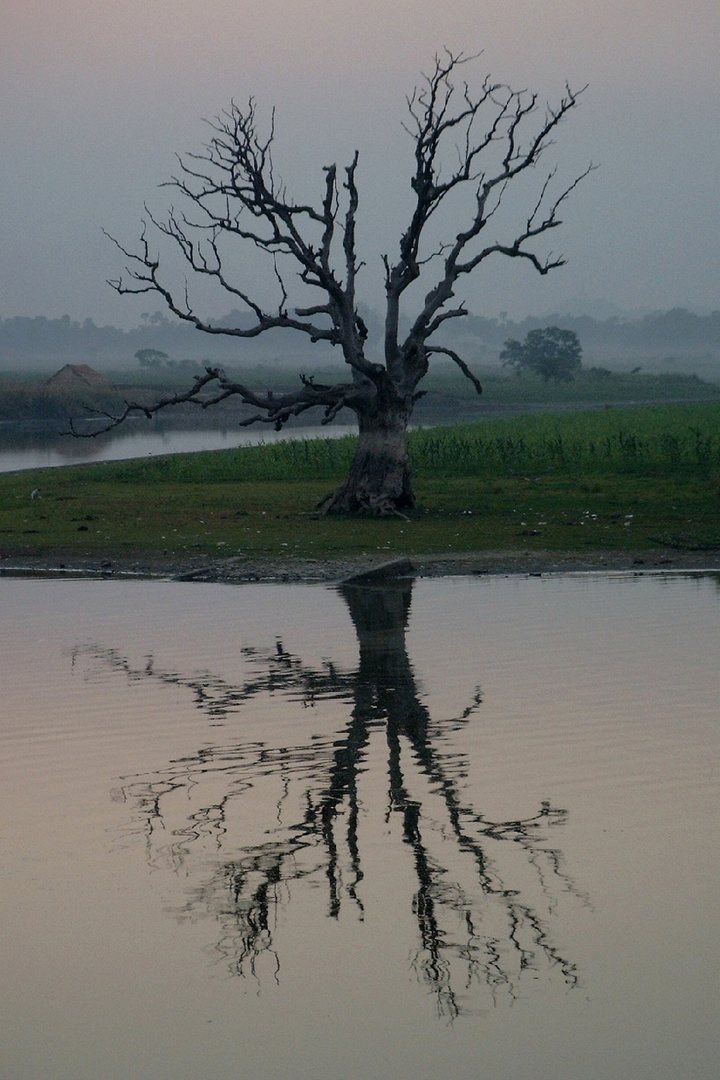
top-left (0, 0), bottom-right (720, 326)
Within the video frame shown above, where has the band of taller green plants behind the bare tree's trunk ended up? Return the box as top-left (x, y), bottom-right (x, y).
top-left (103, 404), bottom-right (720, 483)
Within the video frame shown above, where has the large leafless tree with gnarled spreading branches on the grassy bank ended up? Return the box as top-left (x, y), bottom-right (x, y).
top-left (95, 51), bottom-right (593, 513)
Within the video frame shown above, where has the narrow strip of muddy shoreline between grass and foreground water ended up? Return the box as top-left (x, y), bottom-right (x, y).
top-left (0, 548), bottom-right (720, 584)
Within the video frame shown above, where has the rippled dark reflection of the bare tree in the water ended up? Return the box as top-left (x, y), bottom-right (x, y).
top-left (77, 580), bottom-right (583, 1020)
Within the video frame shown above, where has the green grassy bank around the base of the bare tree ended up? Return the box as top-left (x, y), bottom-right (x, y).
top-left (0, 404), bottom-right (720, 559)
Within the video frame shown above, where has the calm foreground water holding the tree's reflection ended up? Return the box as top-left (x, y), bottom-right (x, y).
top-left (0, 575), bottom-right (720, 1080)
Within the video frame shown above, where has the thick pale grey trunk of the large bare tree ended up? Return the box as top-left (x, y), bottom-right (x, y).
top-left (321, 401), bottom-right (416, 514)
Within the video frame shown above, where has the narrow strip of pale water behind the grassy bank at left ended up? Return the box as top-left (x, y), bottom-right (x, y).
top-left (0, 422), bottom-right (356, 473)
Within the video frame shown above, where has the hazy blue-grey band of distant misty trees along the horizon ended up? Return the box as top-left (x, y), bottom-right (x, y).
top-left (0, 307), bottom-right (720, 381)
